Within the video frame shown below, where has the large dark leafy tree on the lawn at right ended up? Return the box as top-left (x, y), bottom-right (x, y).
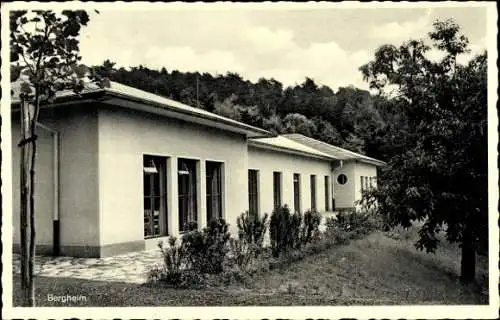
top-left (361, 20), bottom-right (488, 282)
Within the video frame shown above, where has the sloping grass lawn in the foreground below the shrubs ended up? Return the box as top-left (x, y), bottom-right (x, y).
top-left (14, 231), bottom-right (488, 307)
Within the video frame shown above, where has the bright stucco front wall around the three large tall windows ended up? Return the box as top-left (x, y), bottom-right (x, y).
top-left (98, 107), bottom-right (248, 248)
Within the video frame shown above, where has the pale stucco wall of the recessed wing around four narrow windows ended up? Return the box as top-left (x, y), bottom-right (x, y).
top-left (248, 146), bottom-right (331, 215)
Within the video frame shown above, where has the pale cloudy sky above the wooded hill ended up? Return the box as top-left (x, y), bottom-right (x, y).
top-left (80, 5), bottom-right (487, 90)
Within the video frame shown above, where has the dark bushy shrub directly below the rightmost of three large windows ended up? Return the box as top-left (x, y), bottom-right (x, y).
top-left (182, 219), bottom-right (230, 274)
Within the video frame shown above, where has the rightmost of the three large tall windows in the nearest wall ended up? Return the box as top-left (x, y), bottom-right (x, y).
top-left (206, 161), bottom-right (222, 222)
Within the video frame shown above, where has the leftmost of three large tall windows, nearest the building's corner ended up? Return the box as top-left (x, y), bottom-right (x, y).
top-left (143, 155), bottom-right (167, 238)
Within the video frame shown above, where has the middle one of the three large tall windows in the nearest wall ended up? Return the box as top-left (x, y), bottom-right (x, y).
top-left (177, 159), bottom-right (198, 231)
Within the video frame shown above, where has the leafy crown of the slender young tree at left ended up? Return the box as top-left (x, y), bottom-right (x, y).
top-left (9, 10), bottom-right (108, 104)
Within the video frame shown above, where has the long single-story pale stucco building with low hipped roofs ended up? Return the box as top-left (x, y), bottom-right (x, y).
top-left (12, 82), bottom-right (383, 257)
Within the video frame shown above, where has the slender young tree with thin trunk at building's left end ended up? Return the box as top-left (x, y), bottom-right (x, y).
top-left (9, 10), bottom-right (107, 306)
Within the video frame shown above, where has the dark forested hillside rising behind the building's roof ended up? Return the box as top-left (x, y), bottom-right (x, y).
top-left (95, 60), bottom-right (390, 159)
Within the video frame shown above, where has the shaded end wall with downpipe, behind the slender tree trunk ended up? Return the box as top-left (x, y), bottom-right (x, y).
top-left (12, 105), bottom-right (99, 247)
